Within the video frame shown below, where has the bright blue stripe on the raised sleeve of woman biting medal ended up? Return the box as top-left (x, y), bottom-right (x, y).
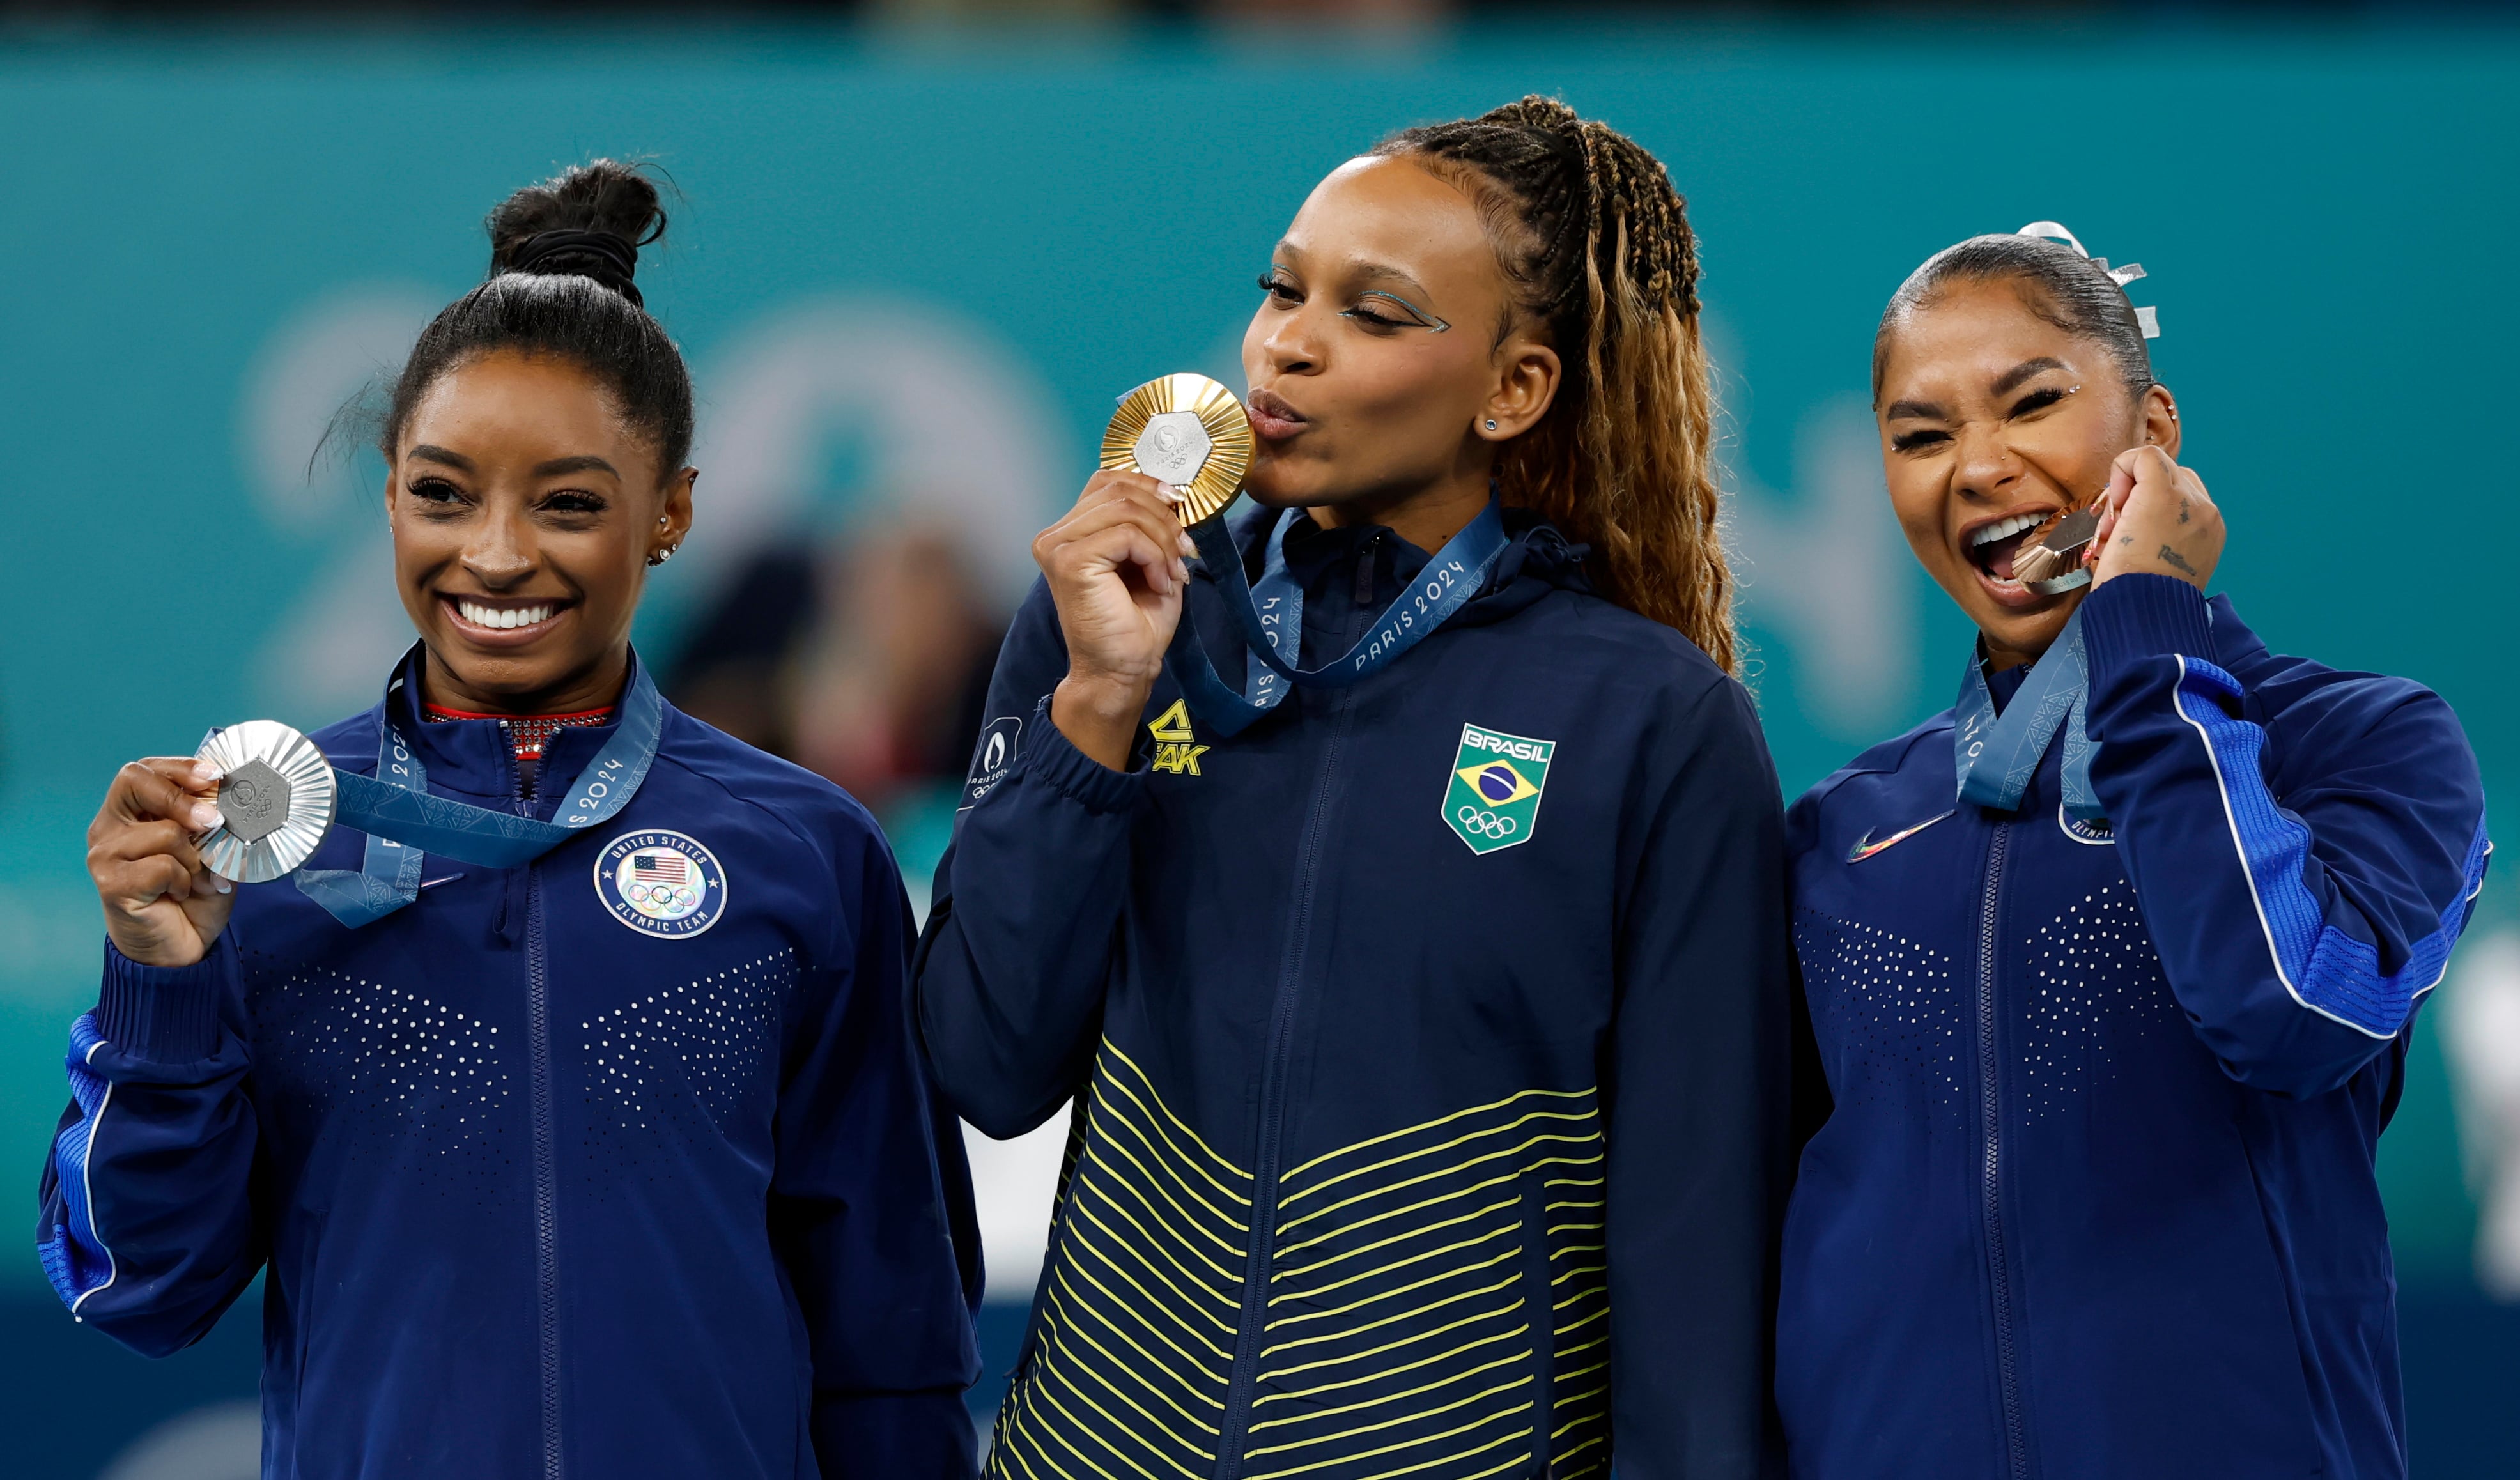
top-left (2172, 656), bottom-right (2493, 1039)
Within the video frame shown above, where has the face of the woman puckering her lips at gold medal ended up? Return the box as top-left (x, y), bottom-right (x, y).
top-left (1242, 157), bottom-right (1558, 517)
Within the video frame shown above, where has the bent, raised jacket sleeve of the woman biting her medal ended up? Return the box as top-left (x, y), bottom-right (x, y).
top-left (2084, 575), bottom-right (2485, 1094)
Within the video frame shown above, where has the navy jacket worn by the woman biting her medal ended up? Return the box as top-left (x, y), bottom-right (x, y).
top-left (1777, 575), bottom-right (2487, 1480)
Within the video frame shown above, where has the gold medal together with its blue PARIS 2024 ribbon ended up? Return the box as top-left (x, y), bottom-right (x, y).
top-left (1124, 373), bottom-right (1512, 736)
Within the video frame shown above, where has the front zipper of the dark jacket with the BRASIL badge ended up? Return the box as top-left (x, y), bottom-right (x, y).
top-left (1217, 539), bottom-right (1379, 1480)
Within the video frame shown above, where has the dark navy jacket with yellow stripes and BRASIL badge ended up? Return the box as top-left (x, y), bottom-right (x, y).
top-left (917, 514), bottom-right (1791, 1480)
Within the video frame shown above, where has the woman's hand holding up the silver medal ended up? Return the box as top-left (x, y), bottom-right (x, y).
top-left (88, 757), bottom-right (237, 966)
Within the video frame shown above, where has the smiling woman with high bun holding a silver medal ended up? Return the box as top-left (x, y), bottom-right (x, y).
top-left (40, 162), bottom-right (978, 1477)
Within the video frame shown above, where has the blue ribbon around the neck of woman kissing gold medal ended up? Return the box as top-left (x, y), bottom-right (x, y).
top-left (1164, 497), bottom-right (1512, 734)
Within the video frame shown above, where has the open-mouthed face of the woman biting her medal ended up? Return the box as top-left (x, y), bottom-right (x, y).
top-left (1875, 280), bottom-right (2180, 668)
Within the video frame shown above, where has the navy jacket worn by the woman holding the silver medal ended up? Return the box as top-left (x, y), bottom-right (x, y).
top-left (38, 660), bottom-right (978, 1480)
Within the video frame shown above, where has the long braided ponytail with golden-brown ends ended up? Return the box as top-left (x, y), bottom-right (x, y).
top-left (1373, 96), bottom-right (1739, 673)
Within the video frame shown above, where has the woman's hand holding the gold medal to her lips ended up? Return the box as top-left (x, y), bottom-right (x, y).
top-left (1033, 472), bottom-right (1197, 771)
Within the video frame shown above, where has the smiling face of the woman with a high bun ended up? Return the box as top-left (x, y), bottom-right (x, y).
top-left (385, 350), bottom-right (695, 714)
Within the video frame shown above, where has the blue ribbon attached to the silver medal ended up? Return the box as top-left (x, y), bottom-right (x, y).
top-left (295, 653), bottom-right (665, 930)
